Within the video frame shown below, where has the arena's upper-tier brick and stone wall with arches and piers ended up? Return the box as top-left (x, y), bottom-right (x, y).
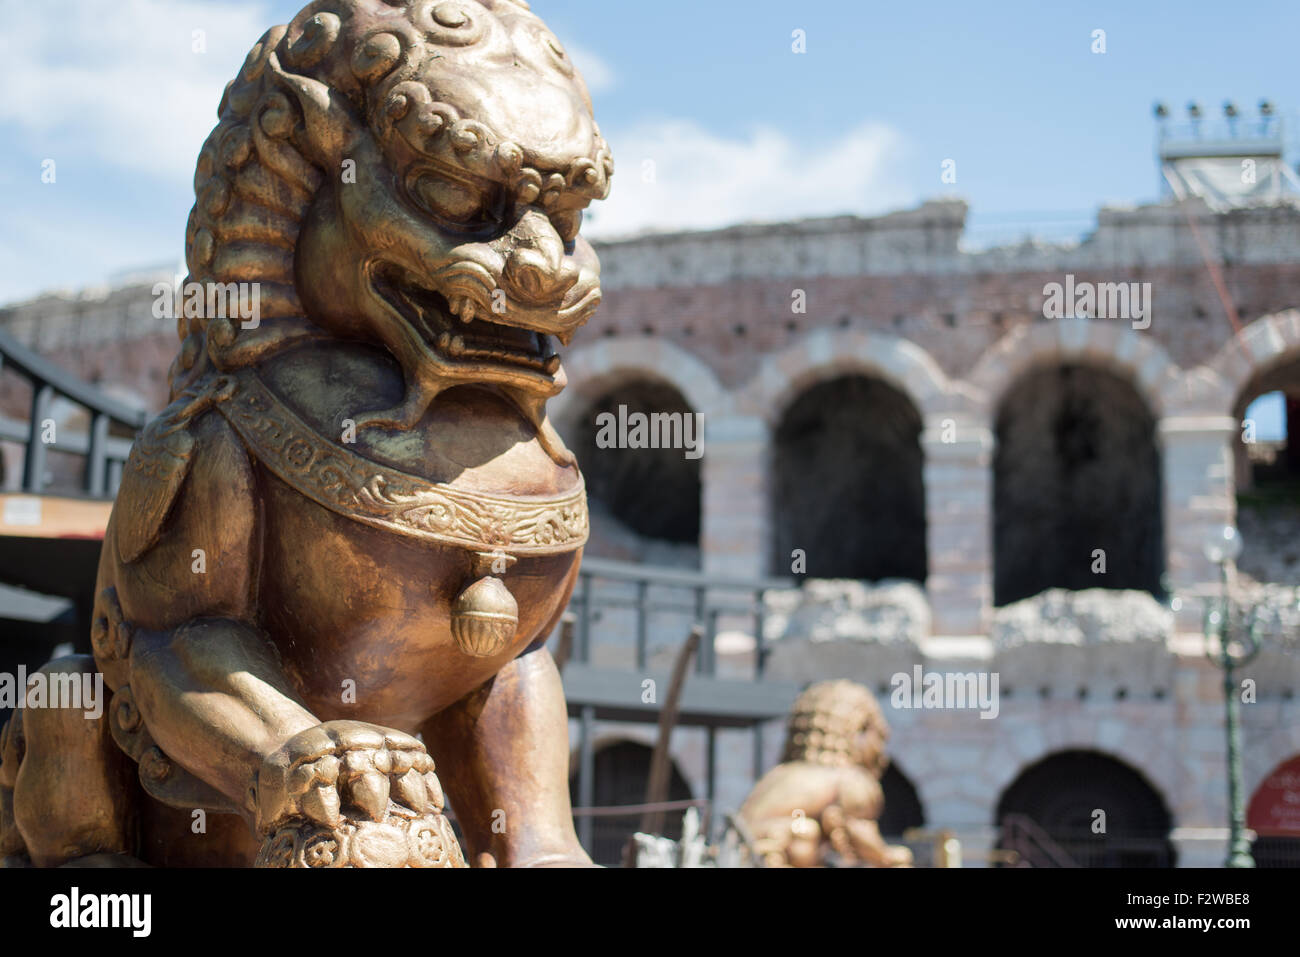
top-left (0, 202), bottom-right (1300, 635)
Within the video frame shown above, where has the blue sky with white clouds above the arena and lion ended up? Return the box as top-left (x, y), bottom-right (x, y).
top-left (0, 0), bottom-right (1300, 314)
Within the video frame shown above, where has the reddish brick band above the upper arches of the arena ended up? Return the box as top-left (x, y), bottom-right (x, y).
top-left (587, 261), bottom-right (1300, 387)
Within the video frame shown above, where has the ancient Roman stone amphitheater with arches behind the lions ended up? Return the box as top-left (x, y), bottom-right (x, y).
top-left (0, 200), bottom-right (1300, 865)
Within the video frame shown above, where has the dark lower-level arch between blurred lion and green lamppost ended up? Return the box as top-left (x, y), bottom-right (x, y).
top-left (995, 750), bottom-right (1174, 867)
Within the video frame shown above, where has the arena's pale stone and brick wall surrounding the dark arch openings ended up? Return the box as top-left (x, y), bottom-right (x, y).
top-left (0, 202), bottom-right (1300, 865)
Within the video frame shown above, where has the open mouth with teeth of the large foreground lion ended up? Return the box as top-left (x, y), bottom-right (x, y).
top-left (374, 272), bottom-right (560, 376)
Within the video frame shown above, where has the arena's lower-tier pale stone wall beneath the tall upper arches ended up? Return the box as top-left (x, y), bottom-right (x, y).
top-left (571, 581), bottom-right (1300, 867)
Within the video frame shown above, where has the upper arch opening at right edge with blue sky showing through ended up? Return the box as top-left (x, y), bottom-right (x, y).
top-left (1232, 356), bottom-right (1300, 585)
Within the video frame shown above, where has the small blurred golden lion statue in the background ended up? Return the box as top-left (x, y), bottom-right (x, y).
top-left (740, 681), bottom-right (911, 867)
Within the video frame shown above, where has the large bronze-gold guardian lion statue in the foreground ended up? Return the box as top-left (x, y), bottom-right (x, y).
top-left (0, 0), bottom-right (614, 866)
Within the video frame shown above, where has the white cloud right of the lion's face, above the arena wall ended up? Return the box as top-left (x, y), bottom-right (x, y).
top-left (584, 120), bottom-right (915, 238)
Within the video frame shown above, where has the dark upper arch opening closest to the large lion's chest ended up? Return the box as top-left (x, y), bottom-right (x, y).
top-left (571, 380), bottom-right (703, 568)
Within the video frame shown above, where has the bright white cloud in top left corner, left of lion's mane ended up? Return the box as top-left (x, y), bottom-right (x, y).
top-left (0, 0), bottom-right (273, 181)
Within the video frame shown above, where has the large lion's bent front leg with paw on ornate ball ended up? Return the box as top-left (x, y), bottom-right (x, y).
top-left (106, 619), bottom-right (464, 867)
